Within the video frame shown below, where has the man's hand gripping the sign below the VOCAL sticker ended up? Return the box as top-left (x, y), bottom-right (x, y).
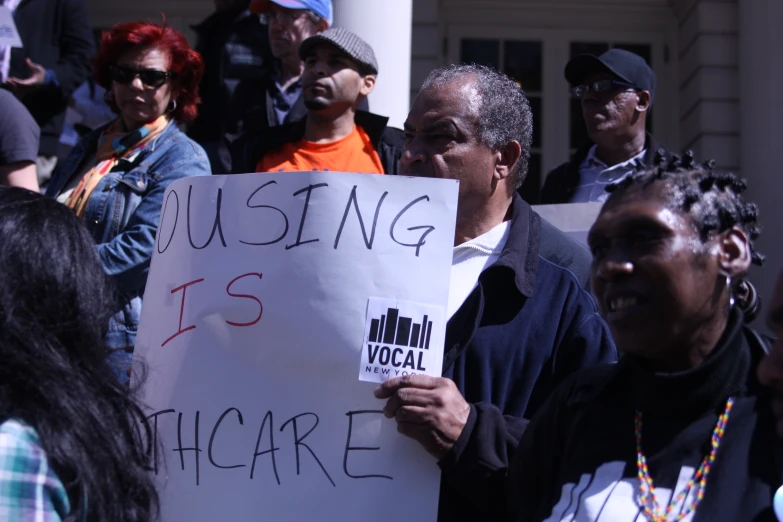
top-left (375, 375), bottom-right (470, 460)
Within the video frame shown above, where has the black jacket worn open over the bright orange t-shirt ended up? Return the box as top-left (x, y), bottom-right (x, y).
top-left (231, 111), bottom-right (405, 174)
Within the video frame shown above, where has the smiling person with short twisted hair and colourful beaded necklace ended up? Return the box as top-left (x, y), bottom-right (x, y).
top-left (510, 154), bottom-right (781, 522)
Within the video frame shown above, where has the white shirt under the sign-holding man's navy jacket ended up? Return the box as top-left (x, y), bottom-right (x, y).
top-left (447, 221), bottom-right (511, 319)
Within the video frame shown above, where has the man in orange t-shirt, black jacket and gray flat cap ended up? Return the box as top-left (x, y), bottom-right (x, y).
top-left (231, 28), bottom-right (405, 174)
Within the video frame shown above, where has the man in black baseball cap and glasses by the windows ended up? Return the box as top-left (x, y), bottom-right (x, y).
top-left (541, 49), bottom-right (669, 203)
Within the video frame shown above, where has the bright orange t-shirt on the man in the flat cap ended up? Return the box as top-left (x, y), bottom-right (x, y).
top-left (256, 125), bottom-right (383, 174)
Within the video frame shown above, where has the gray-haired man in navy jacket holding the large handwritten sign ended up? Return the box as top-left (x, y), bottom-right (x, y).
top-left (375, 65), bottom-right (617, 521)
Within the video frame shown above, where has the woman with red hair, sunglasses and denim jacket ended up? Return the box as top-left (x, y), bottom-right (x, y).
top-left (46, 20), bottom-right (210, 381)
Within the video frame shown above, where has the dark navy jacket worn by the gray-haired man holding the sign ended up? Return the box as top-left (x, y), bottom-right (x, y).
top-left (438, 194), bottom-right (617, 522)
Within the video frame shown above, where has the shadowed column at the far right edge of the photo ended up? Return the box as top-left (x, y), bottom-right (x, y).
top-left (737, 0), bottom-right (783, 316)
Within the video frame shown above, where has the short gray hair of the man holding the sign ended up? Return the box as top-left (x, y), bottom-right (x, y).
top-left (421, 63), bottom-right (533, 188)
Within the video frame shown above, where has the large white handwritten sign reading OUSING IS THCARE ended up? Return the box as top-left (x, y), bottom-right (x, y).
top-left (134, 172), bottom-right (458, 522)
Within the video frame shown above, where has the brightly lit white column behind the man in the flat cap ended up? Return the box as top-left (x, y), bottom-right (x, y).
top-left (334, 0), bottom-right (413, 128)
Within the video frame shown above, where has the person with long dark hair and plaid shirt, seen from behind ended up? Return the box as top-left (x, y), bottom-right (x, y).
top-left (0, 187), bottom-right (158, 522)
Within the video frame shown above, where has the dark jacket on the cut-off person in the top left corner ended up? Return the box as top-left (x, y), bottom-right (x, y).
top-left (8, 0), bottom-right (94, 156)
